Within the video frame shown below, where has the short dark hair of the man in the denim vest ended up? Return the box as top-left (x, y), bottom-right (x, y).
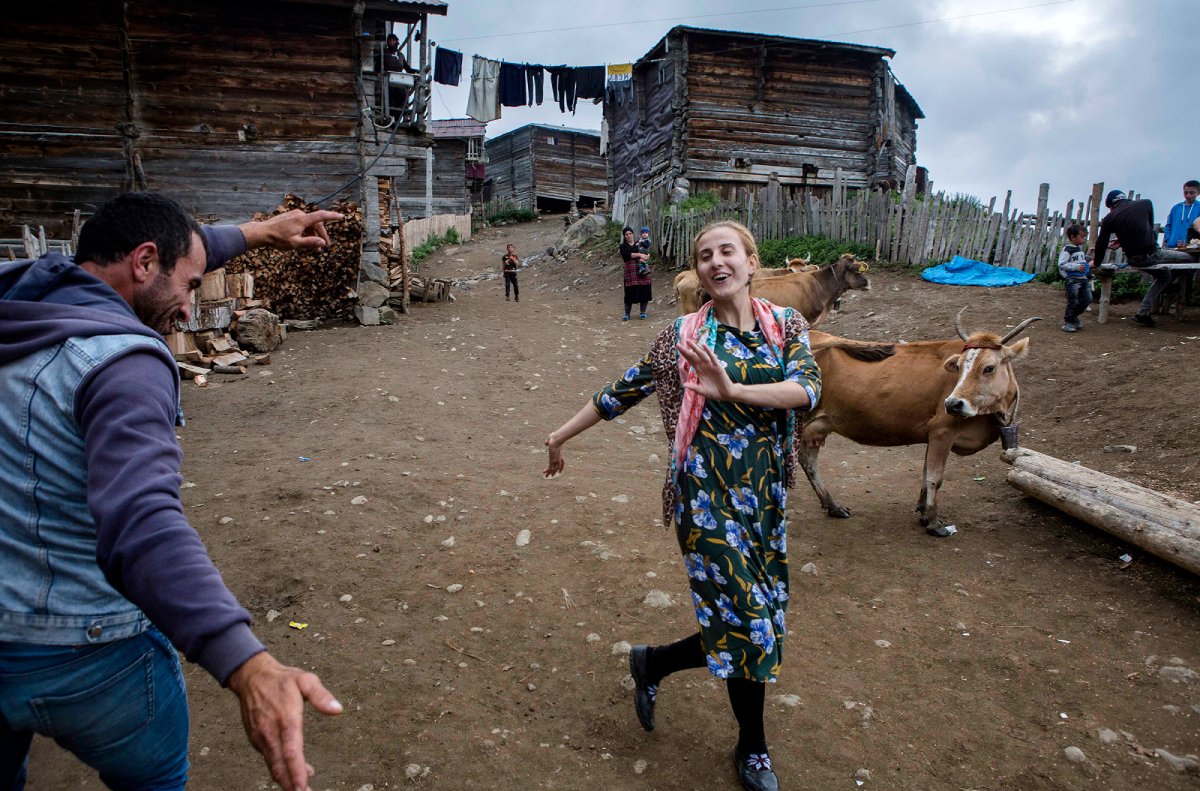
top-left (76, 192), bottom-right (209, 274)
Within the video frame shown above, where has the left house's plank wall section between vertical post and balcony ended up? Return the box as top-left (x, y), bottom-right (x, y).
top-left (126, 0), bottom-right (358, 221)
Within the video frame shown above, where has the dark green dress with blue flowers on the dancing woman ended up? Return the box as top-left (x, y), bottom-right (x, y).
top-left (593, 324), bottom-right (821, 682)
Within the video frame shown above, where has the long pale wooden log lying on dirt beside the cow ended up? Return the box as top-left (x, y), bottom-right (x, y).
top-left (1001, 448), bottom-right (1200, 574)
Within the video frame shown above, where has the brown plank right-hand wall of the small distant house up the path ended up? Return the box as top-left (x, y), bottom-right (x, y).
top-left (532, 126), bottom-right (608, 200)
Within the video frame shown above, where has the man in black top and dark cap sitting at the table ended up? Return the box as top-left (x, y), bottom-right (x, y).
top-left (1092, 190), bottom-right (1195, 326)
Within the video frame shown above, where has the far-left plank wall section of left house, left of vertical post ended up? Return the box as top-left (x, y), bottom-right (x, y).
top-left (0, 0), bottom-right (126, 238)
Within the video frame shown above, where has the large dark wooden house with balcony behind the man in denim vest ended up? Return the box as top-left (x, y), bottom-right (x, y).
top-left (0, 0), bottom-right (462, 236)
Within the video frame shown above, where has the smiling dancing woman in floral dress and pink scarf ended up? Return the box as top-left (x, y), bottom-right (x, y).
top-left (545, 222), bottom-right (821, 791)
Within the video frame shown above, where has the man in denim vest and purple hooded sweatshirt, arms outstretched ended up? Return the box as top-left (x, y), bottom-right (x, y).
top-left (0, 192), bottom-right (342, 791)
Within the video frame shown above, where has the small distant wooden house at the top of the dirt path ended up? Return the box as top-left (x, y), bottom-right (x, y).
top-left (487, 124), bottom-right (608, 211)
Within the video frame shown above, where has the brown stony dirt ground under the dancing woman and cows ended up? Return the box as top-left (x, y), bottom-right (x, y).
top-left (29, 218), bottom-right (1200, 791)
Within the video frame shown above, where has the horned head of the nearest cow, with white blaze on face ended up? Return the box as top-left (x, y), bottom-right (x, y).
top-left (946, 307), bottom-right (1042, 421)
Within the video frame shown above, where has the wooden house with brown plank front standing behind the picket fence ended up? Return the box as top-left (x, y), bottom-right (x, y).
top-left (605, 26), bottom-right (924, 198)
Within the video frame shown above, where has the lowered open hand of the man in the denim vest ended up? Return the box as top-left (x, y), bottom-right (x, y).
top-left (229, 651), bottom-right (342, 791)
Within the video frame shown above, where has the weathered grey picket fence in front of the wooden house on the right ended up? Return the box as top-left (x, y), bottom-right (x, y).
top-left (613, 168), bottom-right (1140, 272)
